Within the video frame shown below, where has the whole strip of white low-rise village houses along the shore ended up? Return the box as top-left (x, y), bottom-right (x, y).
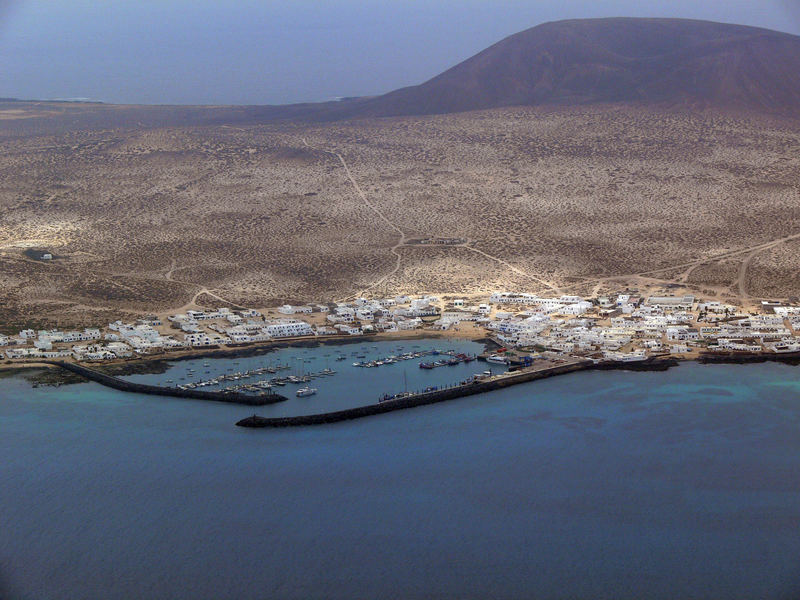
top-left (0, 292), bottom-right (800, 364)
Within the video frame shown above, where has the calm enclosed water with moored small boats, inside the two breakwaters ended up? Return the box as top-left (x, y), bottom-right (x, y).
top-left (114, 338), bottom-right (506, 416)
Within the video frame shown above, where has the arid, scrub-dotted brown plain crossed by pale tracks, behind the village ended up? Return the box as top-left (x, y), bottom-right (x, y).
top-left (0, 103), bottom-right (800, 329)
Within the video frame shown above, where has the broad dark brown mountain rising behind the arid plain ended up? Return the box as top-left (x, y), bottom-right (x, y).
top-left (346, 18), bottom-right (800, 116)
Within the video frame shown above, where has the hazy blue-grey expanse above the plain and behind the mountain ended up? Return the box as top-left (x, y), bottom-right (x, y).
top-left (0, 0), bottom-right (800, 104)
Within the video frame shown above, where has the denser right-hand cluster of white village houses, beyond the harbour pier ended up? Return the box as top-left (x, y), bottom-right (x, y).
top-left (479, 293), bottom-right (800, 361)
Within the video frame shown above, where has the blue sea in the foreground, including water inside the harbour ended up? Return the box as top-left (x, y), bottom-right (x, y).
top-left (0, 341), bottom-right (800, 600)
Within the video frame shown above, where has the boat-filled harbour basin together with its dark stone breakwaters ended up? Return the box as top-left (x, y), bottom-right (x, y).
top-left (48, 339), bottom-right (678, 428)
